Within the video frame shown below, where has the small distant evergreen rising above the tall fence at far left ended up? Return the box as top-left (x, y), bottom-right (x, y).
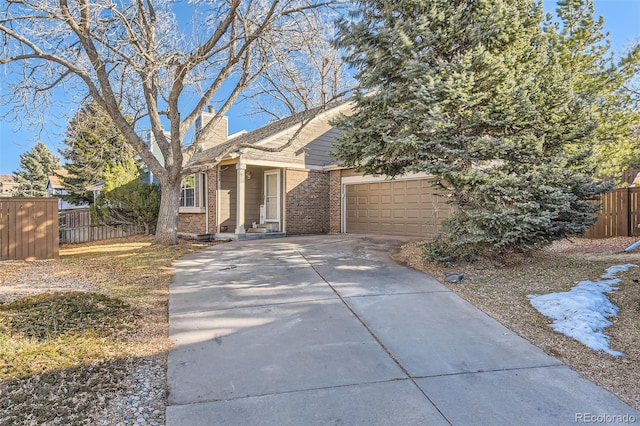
top-left (13, 142), bottom-right (60, 197)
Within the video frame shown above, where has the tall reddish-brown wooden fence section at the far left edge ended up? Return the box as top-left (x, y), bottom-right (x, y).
top-left (0, 197), bottom-right (58, 260)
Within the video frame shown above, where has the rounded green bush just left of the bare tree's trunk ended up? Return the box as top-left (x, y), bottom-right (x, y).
top-left (91, 159), bottom-right (160, 234)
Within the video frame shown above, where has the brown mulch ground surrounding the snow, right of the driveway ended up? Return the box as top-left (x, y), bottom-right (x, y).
top-left (396, 238), bottom-right (640, 409)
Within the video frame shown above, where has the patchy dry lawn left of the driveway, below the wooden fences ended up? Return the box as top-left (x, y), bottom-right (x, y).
top-left (0, 236), bottom-right (220, 424)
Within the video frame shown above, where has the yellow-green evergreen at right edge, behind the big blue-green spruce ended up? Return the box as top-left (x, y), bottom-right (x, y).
top-left (546, 0), bottom-right (640, 178)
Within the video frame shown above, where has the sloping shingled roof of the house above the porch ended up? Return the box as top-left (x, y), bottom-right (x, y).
top-left (194, 99), bottom-right (350, 163)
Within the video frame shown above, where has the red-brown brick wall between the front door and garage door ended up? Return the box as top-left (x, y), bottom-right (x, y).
top-left (285, 169), bottom-right (330, 234)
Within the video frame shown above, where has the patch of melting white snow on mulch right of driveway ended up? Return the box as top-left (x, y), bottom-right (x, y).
top-left (528, 263), bottom-right (637, 356)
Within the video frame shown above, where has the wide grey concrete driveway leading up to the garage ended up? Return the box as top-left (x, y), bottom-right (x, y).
top-left (167, 235), bottom-right (640, 426)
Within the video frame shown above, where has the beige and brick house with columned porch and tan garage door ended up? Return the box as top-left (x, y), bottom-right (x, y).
top-left (178, 103), bottom-right (452, 239)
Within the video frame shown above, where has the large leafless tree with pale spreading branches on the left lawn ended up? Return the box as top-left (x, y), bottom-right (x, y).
top-left (0, 0), bottom-right (348, 244)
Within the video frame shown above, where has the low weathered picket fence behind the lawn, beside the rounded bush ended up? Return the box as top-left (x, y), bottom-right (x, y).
top-left (60, 209), bottom-right (144, 244)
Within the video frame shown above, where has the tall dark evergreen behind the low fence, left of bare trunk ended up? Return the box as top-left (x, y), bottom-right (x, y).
top-left (60, 101), bottom-right (135, 205)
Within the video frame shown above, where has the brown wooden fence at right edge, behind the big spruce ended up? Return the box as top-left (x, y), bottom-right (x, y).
top-left (585, 188), bottom-right (640, 238)
